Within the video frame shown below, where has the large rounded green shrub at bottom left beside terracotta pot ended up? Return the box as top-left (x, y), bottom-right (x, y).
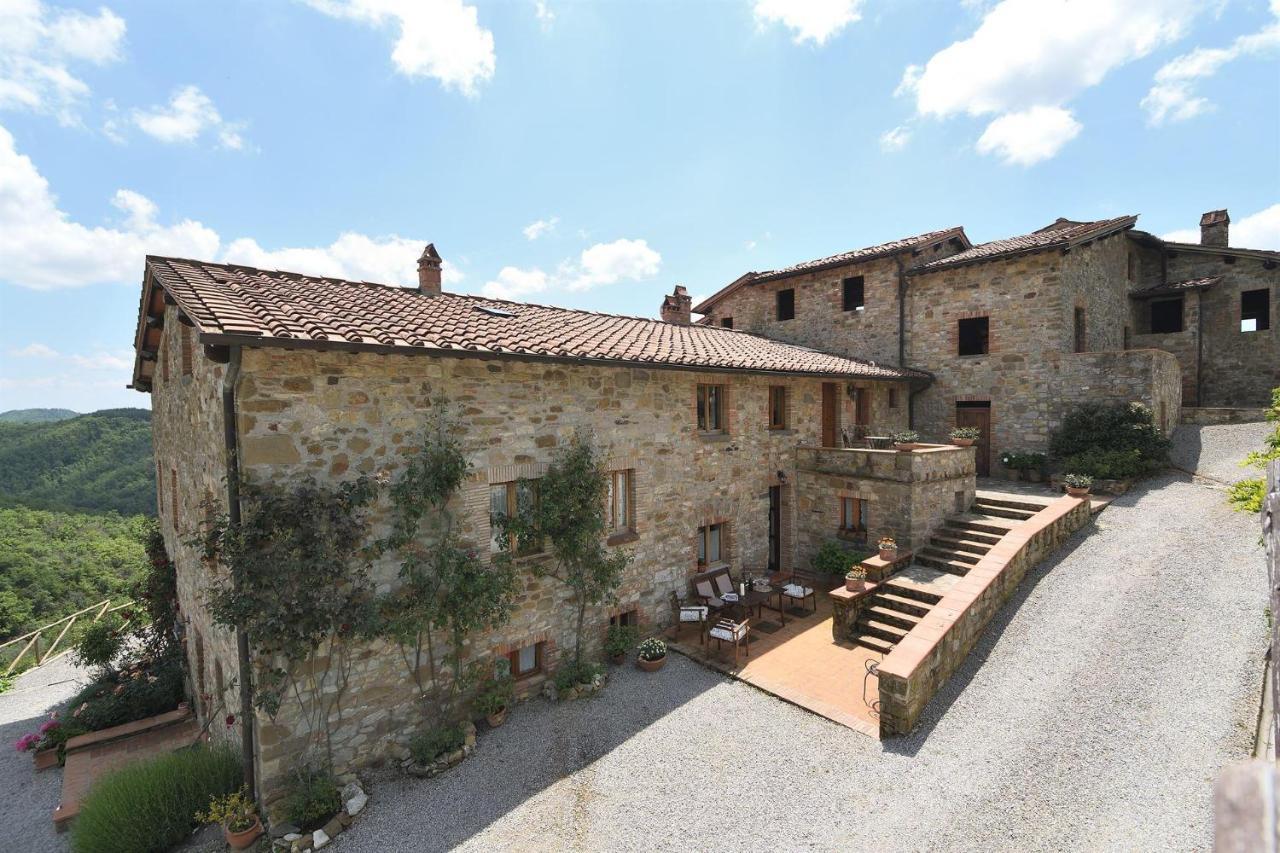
top-left (72, 744), bottom-right (242, 853)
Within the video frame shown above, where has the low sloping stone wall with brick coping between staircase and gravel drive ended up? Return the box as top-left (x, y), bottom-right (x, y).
top-left (879, 497), bottom-right (1089, 736)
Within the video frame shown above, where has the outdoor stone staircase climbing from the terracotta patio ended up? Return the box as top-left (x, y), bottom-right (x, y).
top-left (852, 492), bottom-right (1048, 654)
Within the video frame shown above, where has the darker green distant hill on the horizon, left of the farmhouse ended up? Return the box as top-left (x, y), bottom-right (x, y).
top-left (0, 409), bottom-right (156, 515)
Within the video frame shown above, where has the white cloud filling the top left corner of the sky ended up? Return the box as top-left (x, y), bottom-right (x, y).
top-left (0, 0), bottom-right (125, 124)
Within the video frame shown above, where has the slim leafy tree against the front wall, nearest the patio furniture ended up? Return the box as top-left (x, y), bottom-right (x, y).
top-left (499, 432), bottom-right (631, 669)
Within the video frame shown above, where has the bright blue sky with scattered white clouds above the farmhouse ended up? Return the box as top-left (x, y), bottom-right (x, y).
top-left (0, 0), bottom-right (1280, 411)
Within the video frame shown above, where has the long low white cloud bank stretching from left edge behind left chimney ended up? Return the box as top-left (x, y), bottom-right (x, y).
top-left (0, 120), bottom-right (462, 291)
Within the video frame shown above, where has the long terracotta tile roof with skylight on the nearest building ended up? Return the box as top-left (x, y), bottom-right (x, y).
top-left (134, 256), bottom-right (925, 379)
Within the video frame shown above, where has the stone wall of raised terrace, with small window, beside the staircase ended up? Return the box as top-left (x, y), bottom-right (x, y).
top-left (796, 446), bottom-right (975, 558)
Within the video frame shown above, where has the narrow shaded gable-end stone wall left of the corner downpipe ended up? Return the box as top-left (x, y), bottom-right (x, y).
top-left (151, 306), bottom-right (239, 736)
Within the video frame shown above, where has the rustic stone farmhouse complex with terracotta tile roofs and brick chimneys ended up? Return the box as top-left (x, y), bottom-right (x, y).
top-left (133, 211), bottom-right (1280, 794)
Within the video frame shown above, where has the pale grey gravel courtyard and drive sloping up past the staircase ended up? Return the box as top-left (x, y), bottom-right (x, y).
top-left (335, 424), bottom-right (1267, 853)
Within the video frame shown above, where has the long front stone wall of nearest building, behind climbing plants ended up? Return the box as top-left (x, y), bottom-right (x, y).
top-left (220, 348), bottom-right (906, 781)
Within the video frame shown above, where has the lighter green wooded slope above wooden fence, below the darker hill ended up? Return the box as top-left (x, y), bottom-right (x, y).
top-left (0, 507), bottom-right (152, 640)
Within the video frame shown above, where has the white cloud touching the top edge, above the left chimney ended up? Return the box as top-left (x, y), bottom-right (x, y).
top-left (303, 0), bottom-right (497, 97)
